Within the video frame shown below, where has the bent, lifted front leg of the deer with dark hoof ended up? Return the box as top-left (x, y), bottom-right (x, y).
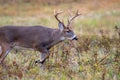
top-left (35, 49), bottom-right (50, 64)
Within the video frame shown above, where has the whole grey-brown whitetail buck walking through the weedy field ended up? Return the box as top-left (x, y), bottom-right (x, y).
top-left (0, 11), bottom-right (80, 64)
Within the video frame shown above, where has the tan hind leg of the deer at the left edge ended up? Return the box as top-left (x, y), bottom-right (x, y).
top-left (0, 43), bottom-right (12, 64)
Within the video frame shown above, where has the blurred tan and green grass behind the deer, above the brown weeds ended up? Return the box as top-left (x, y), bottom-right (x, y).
top-left (0, 0), bottom-right (120, 34)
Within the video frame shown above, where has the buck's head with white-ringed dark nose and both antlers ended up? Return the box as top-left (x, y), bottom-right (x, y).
top-left (54, 10), bottom-right (81, 40)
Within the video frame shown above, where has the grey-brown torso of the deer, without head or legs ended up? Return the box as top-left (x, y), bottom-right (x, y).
top-left (0, 26), bottom-right (61, 49)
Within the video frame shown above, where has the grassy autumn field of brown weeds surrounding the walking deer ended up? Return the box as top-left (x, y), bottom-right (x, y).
top-left (0, 0), bottom-right (120, 80)
